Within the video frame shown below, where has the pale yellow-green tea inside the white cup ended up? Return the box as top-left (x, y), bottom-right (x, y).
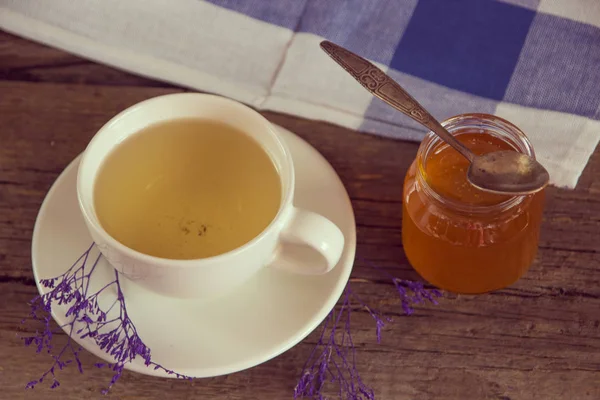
top-left (94, 119), bottom-right (281, 259)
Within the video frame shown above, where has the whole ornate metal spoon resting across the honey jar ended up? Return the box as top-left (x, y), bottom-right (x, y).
top-left (321, 40), bottom-right (550, 195)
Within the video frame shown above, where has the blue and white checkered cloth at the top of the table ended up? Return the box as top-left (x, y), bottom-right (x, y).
top-left (0, 0), bottom-right (600, 187)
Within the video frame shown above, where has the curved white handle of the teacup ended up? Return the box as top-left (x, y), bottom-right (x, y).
top-left (270, 207), bottom-right (344, 275)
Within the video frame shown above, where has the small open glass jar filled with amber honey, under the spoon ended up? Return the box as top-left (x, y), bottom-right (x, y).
top-left (402, 114), bottom-right (544, 293)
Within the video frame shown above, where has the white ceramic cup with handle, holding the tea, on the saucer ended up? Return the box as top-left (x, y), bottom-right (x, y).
top-left (77, 93), bottom-right (344, 298)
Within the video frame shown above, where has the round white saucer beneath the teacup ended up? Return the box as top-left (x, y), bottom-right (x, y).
top-left (32, 124), bottom-right (356, 378)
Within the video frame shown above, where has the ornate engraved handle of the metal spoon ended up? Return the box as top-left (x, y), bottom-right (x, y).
top-left (321, 40), bottom-right (474, 162)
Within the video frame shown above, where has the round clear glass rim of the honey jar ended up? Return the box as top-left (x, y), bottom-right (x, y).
top-left (417, 113), bottom-right (535, 214)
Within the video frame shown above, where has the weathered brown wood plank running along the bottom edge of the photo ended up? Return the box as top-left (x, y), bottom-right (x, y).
top-left (0, 283), bottom-right (600, 400)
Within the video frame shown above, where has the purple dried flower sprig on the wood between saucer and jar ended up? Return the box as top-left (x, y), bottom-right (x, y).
top-left (294, 274), bottom-right (442, 400)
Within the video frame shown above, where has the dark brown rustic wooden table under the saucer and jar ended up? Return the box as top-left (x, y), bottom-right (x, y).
top-left (0, 32), bottom-right (600, 400)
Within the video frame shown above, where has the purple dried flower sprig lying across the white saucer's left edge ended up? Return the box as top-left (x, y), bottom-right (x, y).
top-left (22, 244), bottom-right (192, 394)
